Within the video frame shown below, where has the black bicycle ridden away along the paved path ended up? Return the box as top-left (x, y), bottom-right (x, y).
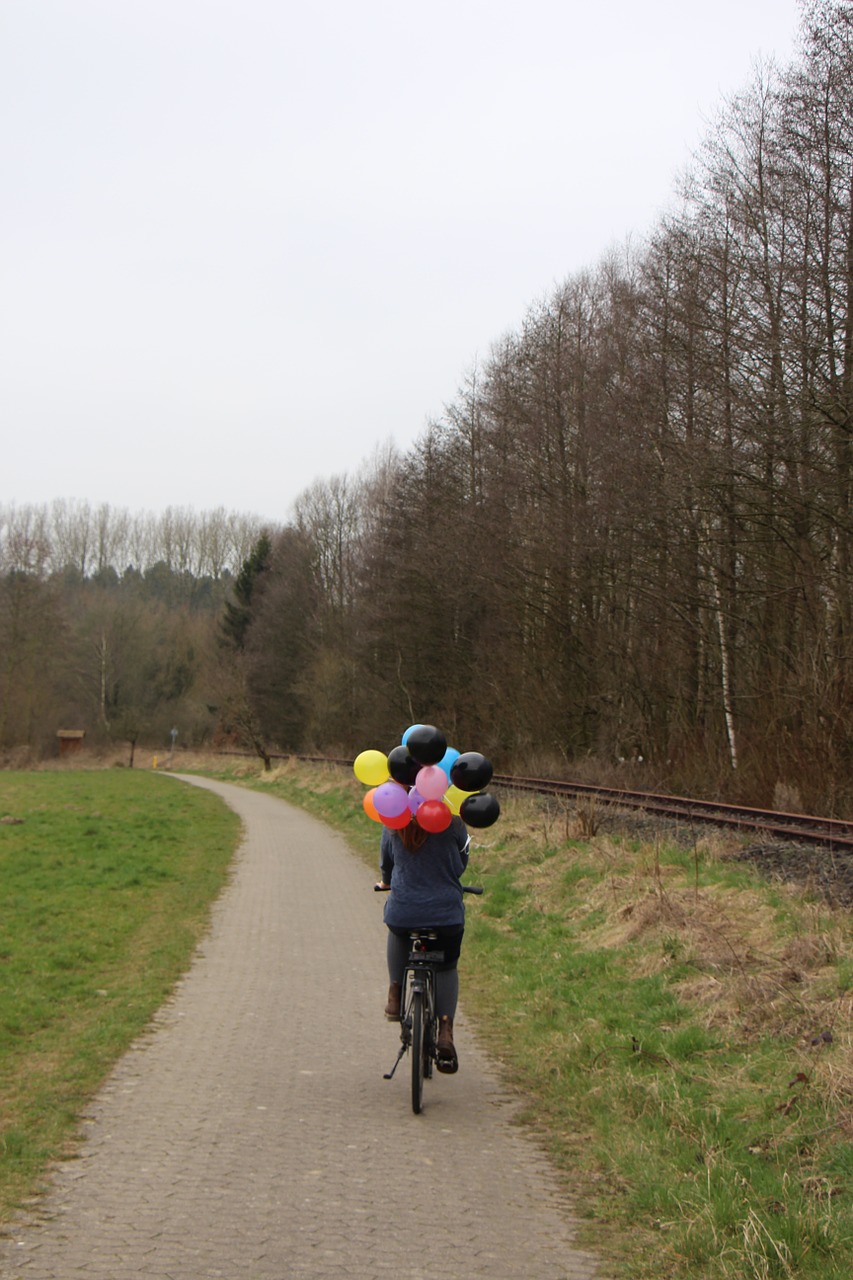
top-left (374, 884), bottom-right (483, 1115)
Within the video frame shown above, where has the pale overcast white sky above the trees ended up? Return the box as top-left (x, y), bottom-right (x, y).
top-left (0, 0), bottom-right (799, 521)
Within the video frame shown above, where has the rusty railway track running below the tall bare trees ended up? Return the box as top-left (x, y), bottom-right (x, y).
top-left (493, 773), bottom-right (853, 850)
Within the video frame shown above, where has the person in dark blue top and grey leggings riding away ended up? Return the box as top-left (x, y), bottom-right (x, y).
top-left (379, 818), bottom-right (470, 1075)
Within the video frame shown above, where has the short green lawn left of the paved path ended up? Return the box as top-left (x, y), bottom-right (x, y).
top-left (0, 769), bottom-right (238, 1220)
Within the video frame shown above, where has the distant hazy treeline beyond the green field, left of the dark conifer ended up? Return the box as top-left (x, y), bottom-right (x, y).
top-left (0, 500), bottom-right (272, 754)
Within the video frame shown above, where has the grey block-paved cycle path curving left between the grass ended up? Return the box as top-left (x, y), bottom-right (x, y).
top-left (0, 777), bottom-right (599, 1280)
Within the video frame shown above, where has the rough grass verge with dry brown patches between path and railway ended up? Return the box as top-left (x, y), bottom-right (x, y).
top-left (211, 765), bottom-right (853, 1280)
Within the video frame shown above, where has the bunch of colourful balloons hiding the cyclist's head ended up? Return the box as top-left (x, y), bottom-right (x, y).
top-left (352, 724), bottom-right (501, 832)
